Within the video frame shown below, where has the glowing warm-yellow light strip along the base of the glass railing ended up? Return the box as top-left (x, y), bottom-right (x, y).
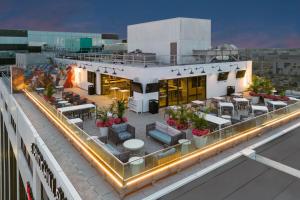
top-left (24, 90), bottom-right (300, 189)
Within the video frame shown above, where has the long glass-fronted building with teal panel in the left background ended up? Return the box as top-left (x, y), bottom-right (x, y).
top-left (0, 29), bottom-right (122, 65)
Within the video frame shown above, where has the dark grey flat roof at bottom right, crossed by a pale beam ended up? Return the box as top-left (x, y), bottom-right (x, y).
top-left (160, 128), bottom-right (300, 200)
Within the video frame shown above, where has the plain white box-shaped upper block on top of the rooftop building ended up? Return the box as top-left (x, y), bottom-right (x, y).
top-left (127, 18), bottom-right (211, 63)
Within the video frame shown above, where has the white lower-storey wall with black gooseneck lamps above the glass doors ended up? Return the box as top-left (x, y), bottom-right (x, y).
top-left (56, 58), bottom-right (252, 112)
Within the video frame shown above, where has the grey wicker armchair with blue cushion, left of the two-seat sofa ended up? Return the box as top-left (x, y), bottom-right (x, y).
top-left (108, 123), bottom-right (135, 145)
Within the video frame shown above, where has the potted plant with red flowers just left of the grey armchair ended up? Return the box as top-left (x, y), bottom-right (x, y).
top-left (96, 107), bottom-right (113, 136)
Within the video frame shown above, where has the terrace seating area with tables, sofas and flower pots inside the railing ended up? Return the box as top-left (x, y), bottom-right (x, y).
top-left (29, 82), bottom-right (294, 179)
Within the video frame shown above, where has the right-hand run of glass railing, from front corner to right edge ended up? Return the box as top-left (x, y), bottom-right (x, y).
top-left (124, 102), bottom-right (300, 179)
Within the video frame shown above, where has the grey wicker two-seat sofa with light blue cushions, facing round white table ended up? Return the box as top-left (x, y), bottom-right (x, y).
top-left (146, 122), bottom-right (186, 146)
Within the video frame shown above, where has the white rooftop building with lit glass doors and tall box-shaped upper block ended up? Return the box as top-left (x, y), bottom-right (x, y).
top-left (56, 18), bottom-right (252, 112)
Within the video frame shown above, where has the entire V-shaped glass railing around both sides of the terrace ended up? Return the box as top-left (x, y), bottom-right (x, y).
top-left (23, 89), bottom-right (300, 182)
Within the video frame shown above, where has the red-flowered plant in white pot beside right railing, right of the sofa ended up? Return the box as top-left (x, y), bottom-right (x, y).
top-left (190, 113), bottom-right (210, 148)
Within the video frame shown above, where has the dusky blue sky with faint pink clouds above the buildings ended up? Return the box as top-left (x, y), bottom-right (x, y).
top-left (0, 0), bottom-right (300, 48)
